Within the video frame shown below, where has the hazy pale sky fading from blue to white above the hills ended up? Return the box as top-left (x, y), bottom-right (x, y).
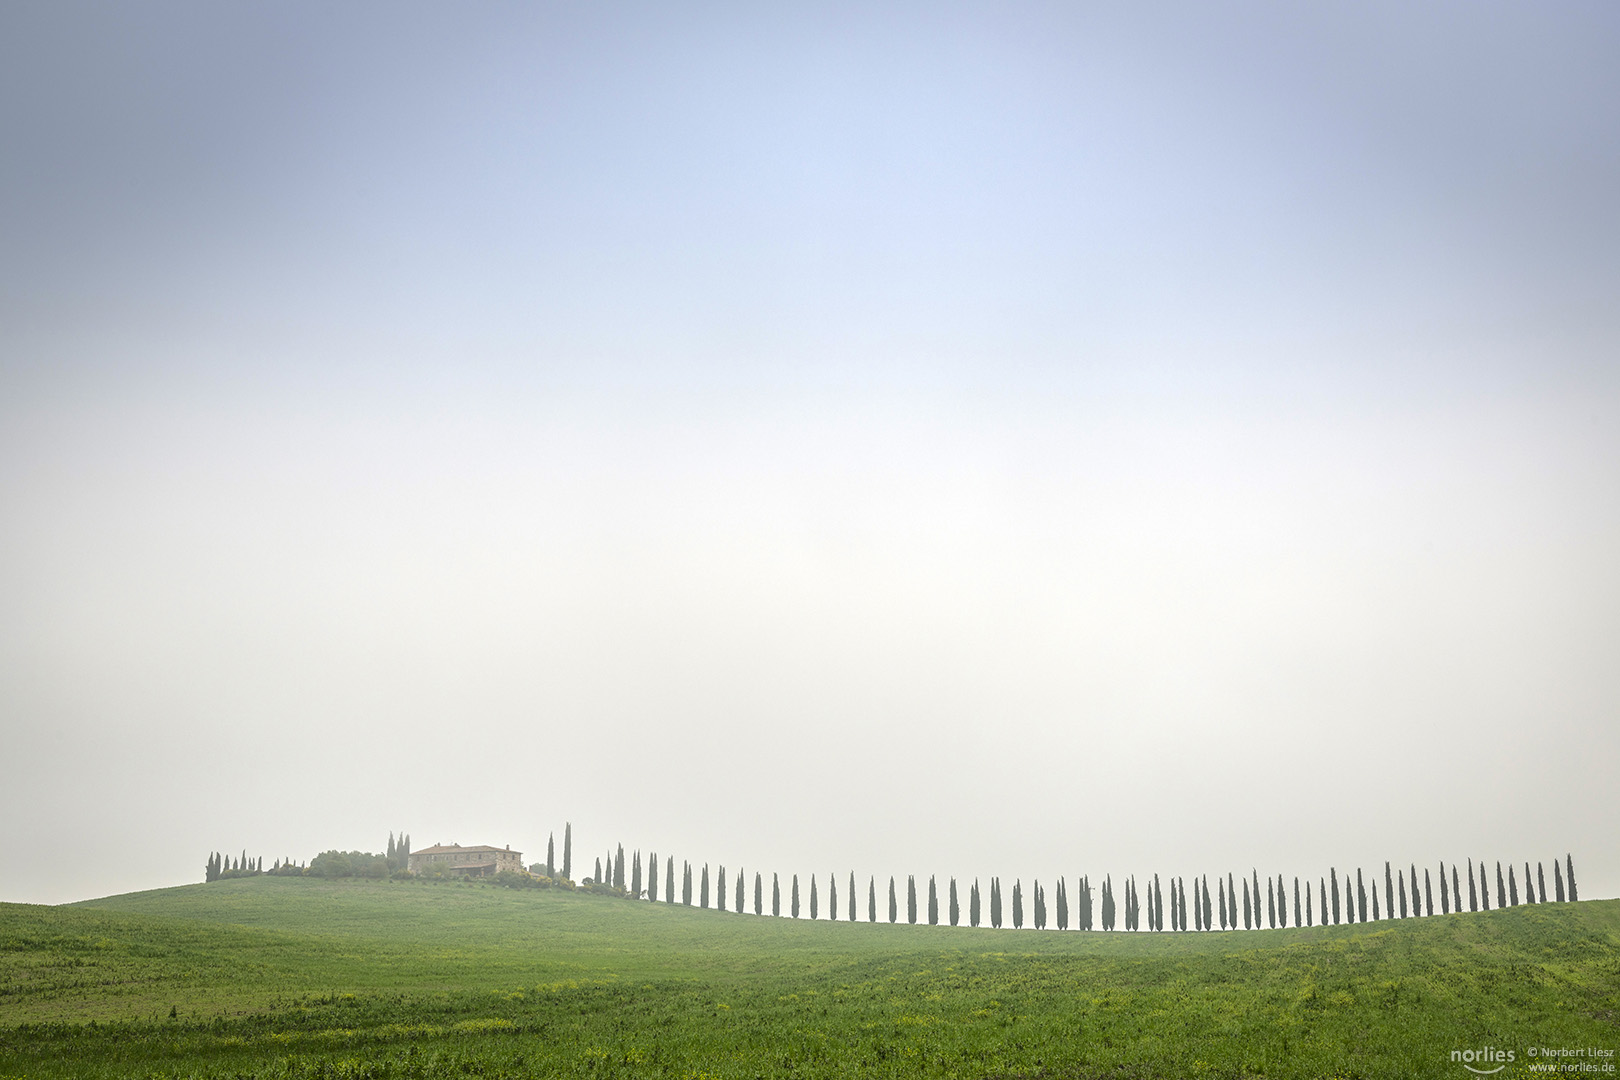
top-left (0, 2), bottom-right (1620, 904)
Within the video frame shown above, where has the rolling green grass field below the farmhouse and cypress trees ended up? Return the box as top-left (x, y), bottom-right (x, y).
top-left (0, 878), bottom-right (1620, 1080)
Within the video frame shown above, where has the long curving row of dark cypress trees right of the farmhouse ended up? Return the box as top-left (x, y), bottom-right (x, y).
top-left (563, 827), bottom-right (1580, 931)
